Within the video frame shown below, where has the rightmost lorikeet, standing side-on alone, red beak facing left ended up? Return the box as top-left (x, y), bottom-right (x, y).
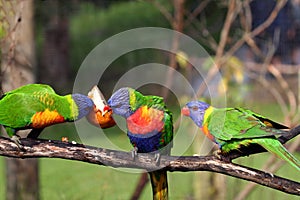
top-left (182, 101), bottom-right (300, 170)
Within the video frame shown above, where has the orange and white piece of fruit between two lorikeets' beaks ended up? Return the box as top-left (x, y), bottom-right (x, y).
top-left (86, 86), bottom-right (116, 129)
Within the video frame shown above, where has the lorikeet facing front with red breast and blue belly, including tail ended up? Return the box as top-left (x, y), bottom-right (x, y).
top-left (108, 88), bottom-right (173, 199)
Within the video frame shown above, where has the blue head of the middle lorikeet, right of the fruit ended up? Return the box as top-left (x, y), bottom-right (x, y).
top-left (107, 87), bottom-right (134, 118)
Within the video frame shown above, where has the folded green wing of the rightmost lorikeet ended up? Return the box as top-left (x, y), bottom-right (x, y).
top-left (208, 108), bottom-right (286, 142)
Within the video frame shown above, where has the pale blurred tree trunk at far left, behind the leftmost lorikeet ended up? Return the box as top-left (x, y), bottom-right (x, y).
top-left (1, 0), bottom-right (39, 200)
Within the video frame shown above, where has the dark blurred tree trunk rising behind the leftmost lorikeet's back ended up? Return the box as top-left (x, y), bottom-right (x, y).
top-left (37, 0), bottom-right (72, 93)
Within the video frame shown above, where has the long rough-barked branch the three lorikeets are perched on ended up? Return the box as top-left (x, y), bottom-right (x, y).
top-left (0, 134), bottom-right (300, 195)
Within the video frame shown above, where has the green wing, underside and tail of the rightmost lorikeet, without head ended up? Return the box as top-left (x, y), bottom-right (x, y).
top-left (209, 108), bottom-right (300, 170)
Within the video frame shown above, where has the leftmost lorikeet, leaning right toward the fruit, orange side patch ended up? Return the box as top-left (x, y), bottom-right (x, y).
top-left (0, 84), bottom-right (94, 142)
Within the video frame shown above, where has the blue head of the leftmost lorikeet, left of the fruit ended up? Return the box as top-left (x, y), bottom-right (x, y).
top-left (72, 94), bottom-right (94, 119)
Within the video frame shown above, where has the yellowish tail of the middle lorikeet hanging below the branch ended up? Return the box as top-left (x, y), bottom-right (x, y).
top-left (149, 170), bottom-right (168, 200)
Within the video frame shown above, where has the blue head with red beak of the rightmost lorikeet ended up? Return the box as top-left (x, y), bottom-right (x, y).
top-left (181, 101), bottom-right (210, 127)
